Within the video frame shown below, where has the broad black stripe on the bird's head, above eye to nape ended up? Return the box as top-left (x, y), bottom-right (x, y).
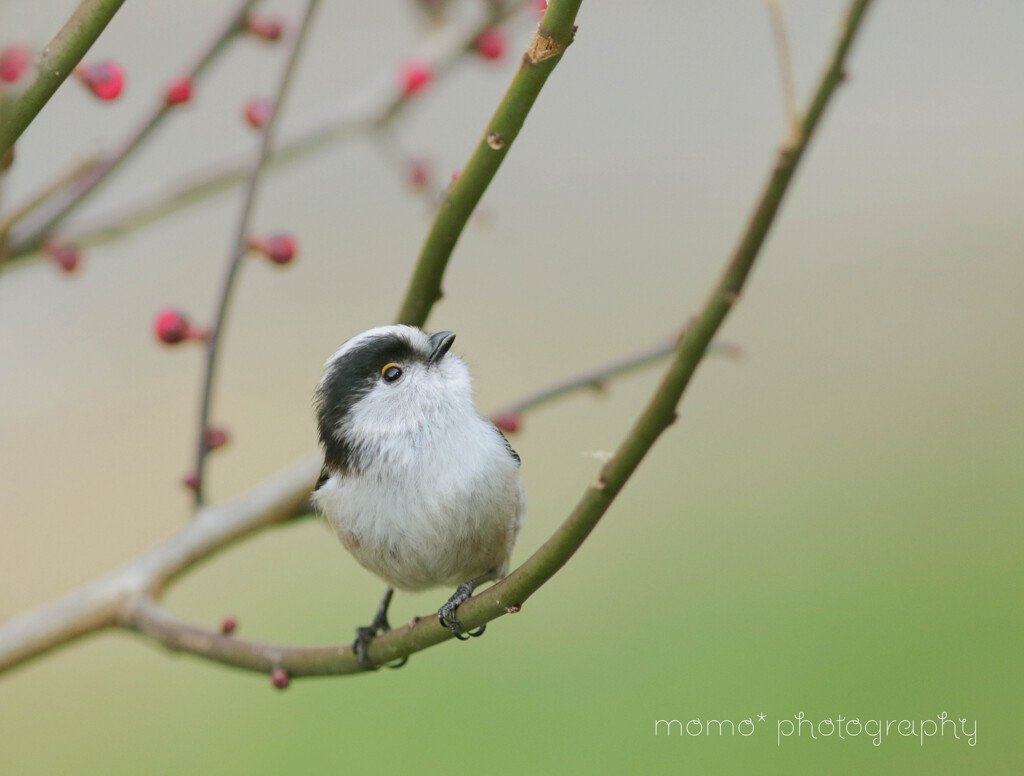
top-left (314, 334), bottom-right (427, 472)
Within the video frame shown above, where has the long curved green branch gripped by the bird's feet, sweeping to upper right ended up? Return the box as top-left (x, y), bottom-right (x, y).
top-left (134, 0), bottom-right (871, 677)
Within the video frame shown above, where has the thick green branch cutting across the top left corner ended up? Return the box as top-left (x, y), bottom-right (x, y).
top-left (0, 0), bottom-right (124, 157)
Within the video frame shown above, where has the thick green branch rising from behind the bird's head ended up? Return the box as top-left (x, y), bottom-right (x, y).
top-left (398, 0), bottom-right (583, 326)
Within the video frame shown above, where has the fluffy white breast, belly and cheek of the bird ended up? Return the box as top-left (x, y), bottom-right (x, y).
top-left (315, 354), bottom-right (525, 590)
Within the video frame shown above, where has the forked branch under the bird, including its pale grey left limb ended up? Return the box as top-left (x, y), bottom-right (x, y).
top-left (0, 0), bottom-right (870, 676)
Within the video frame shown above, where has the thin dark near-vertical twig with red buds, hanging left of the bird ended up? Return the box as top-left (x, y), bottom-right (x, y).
top-left (194, 0), bottom-right (319, 507)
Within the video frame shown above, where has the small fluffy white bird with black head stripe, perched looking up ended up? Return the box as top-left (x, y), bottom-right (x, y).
top-left (313, 326), bottom-right (525, 669)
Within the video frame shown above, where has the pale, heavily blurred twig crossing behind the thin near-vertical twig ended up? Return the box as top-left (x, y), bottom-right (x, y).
top-left (8, 0), bottom-right (526, 259)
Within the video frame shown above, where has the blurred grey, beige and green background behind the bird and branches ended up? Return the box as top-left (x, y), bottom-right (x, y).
top-left (0, 0), bottom-right (1024, 775)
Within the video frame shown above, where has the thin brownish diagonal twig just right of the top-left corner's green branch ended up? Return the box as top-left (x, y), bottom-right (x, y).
top-left (3, 0), bottom-right (258, 261)
